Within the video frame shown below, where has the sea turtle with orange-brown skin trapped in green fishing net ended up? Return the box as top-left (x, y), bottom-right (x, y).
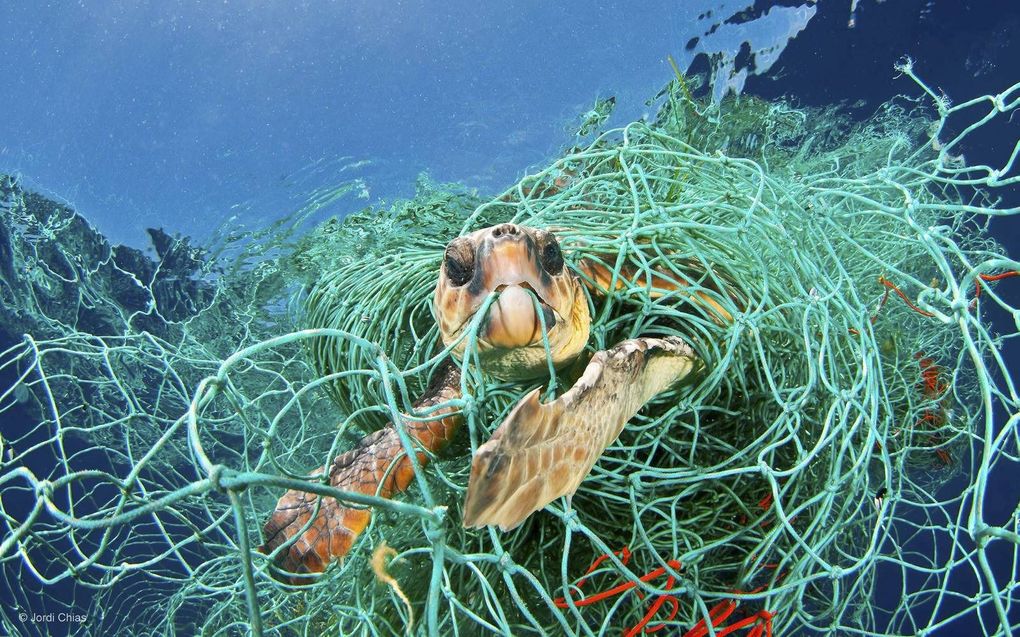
top-left (260, 223), bottom-right (731, 582)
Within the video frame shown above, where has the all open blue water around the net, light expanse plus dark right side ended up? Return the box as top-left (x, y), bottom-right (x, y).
top-left (0, 0), bottom-right (1020, 635)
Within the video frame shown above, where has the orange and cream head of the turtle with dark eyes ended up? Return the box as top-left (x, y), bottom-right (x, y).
top-left (435, 223), bottom-right (592, 379)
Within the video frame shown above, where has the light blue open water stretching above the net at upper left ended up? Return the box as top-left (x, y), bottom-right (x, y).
top-left (0, 0), bottom-right (734, 245)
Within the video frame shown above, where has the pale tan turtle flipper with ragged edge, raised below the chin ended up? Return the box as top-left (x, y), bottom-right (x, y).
top-left (464, 336), bottom-right (702, 531)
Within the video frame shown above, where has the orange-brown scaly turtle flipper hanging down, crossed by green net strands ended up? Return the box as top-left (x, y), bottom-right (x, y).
top-left (259, 361), bottom-right (462, 584)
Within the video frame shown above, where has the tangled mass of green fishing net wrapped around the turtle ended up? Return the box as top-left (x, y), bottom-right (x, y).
top-left (0, 63), bottom-right (1020, 637)
